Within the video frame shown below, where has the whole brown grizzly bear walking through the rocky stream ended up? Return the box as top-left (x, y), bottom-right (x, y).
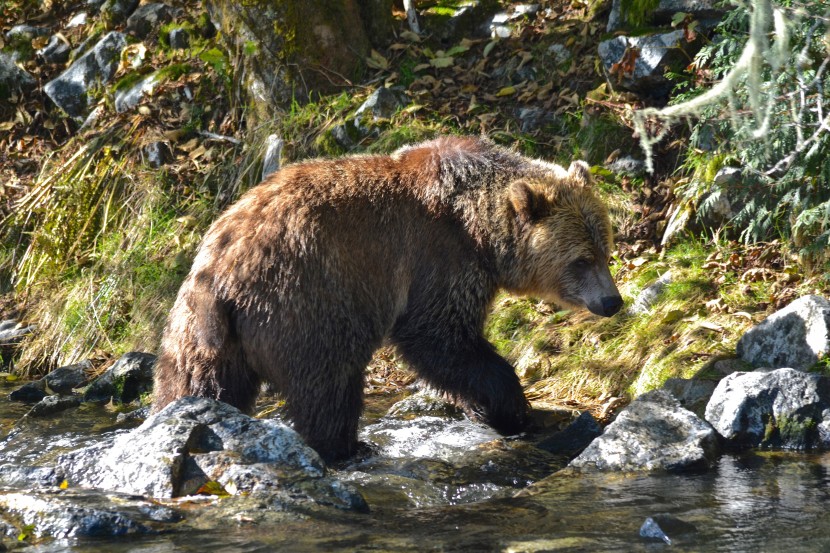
top-left (153, 137), bottom-right (622, 461)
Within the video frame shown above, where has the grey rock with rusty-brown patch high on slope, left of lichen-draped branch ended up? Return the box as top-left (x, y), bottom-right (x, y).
top-left (598, 29), bottom-right (700, 98)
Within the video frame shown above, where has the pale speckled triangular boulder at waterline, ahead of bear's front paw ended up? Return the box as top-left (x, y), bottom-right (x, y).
top-left (570, 390), bottom-right (719, 471)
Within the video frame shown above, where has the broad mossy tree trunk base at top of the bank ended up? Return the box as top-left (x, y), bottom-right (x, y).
top-left (206, 0), bottom-right (392, 118)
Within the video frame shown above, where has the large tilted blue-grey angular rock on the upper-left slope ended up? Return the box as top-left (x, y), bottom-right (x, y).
top-left (43, 31), bottom-right (127, 117)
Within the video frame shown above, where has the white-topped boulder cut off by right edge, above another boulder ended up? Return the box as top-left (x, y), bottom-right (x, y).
top-left (737, 296), bottom-right (830, 370)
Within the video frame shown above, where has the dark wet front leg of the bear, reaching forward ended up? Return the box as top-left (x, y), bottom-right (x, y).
top-left (395, 337), bottom-right (530, 435)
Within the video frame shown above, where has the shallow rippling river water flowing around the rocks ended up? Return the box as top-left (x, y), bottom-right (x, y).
top-left (0, 386), bottom-right (830, 553)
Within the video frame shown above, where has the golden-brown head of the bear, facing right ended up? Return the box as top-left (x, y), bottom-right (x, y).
top-left (508, 161), bottom-right (623, 317)
